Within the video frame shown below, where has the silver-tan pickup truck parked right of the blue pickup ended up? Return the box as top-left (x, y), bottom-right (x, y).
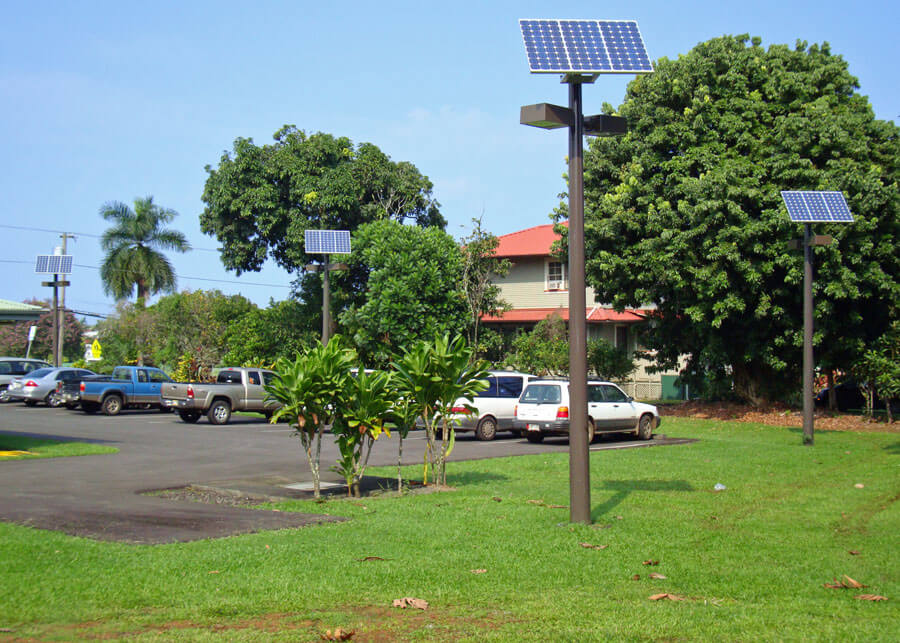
top-left (160, 368), bottom-right (277, 424)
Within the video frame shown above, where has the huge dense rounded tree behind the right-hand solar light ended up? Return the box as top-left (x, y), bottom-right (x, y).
top-left (585, 36), bottom-right (900, 402)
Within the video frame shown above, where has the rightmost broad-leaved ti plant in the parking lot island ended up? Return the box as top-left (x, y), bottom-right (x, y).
top-left (393, 334), bottom-right (488, 485)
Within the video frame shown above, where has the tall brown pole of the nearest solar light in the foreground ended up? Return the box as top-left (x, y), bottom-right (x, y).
top-left (568, 77), bottom-right (591, 523)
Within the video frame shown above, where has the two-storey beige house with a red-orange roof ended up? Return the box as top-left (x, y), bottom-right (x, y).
top-left (481, 224), bottom-right (677, 399)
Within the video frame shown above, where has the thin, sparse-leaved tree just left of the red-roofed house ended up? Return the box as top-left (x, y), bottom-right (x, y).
top-left (462, 217), bottom-right (512, 353)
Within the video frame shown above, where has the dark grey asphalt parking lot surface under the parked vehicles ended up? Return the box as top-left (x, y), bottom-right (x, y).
top-left (0, 404), bottom-right (678, 543)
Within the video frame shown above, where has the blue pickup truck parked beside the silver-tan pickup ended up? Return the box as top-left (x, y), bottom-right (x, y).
top-left (79, 366), bottom-right (172, 415)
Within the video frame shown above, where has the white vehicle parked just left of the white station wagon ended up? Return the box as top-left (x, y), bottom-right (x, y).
top-left (444, 371), bottom-right (535, 440)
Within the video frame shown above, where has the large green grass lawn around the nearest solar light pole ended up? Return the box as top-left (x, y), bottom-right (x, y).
top-left (0, 418), bottom-right (900, 641)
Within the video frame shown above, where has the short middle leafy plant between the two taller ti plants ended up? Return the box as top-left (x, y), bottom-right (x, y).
top-left (332, 368), bottom-right (392, 497)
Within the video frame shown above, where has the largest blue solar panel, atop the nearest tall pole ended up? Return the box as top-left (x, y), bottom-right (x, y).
top-left (519, 20), bottom-right (653, 74)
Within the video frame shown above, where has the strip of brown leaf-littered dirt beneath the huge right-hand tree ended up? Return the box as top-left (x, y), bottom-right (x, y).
top-left (660, 401), bottom-right (900, 433)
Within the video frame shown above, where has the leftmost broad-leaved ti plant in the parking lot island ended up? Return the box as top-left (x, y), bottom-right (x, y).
top-left (266, 335), bottom-right (357, 498)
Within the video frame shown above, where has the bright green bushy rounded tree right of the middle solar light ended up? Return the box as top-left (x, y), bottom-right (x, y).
top-left (335, 221), bottom-right (467, 366)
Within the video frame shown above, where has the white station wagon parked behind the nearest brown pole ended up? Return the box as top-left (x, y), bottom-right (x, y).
top-left (514, 379), bottom-right (662, 442)
